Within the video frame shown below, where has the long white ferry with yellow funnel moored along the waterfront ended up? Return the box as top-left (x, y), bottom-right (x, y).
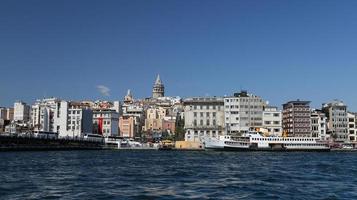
top-left (204, 132), bottom-right (331, 151)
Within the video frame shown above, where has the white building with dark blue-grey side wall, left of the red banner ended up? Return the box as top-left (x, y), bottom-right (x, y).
top-left (55, 101), bottom-right (93, 137)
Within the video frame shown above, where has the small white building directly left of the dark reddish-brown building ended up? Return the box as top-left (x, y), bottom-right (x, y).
top-left (263, 106), bottom-right (283, 136)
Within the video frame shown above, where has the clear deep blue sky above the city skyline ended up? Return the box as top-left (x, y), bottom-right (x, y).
top-left (0, 0), bottom-right (357, 111)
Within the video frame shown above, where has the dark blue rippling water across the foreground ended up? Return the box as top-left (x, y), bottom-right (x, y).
top-left (0, 151), bottom-right (357, 199)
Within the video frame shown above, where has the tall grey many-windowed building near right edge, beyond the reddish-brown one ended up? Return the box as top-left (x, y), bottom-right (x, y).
top-left (322, 100), bottom-right (348, 142)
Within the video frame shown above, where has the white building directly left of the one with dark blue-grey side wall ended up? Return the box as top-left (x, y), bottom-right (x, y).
top-left (30, 98), bottom-right (60, 132)
